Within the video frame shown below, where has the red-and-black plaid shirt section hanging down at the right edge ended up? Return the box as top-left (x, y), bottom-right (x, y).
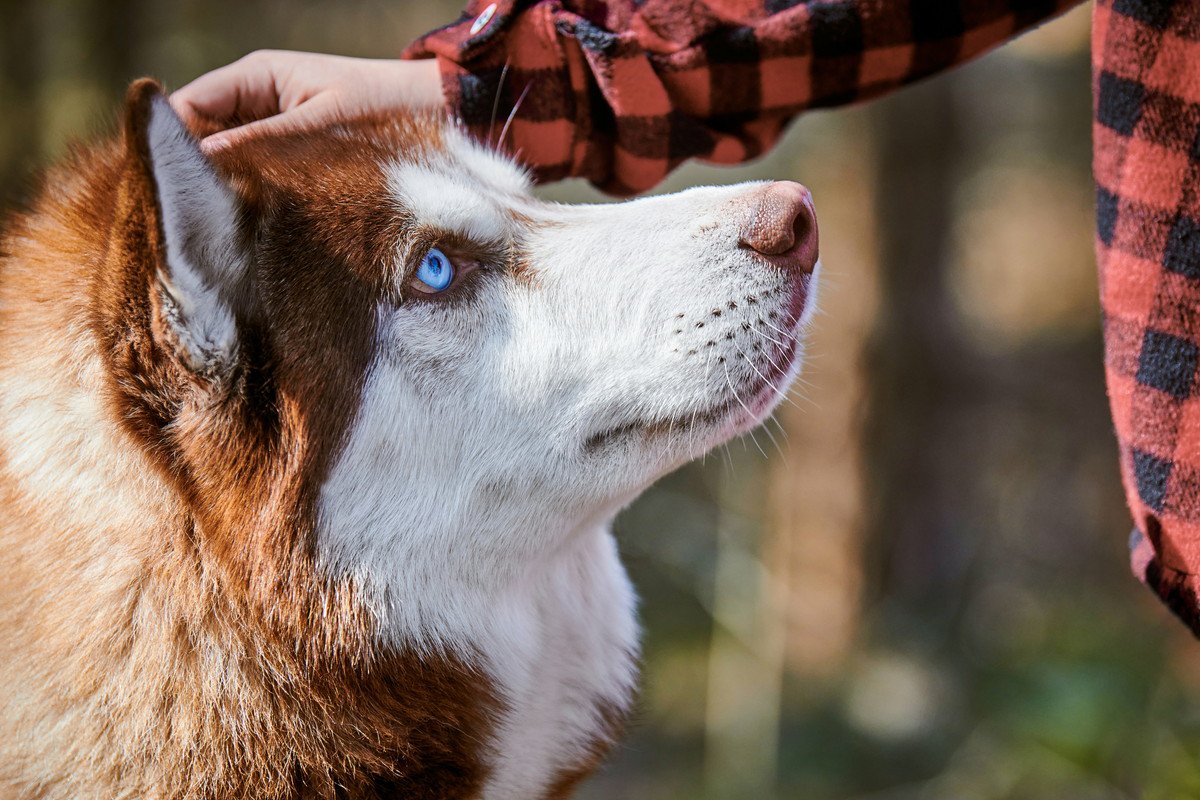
top-left (1092, 0), bottom-right (1200, 636)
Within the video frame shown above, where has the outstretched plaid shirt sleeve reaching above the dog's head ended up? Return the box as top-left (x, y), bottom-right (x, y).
top-left (406, 0), bottom-right (1079, 194)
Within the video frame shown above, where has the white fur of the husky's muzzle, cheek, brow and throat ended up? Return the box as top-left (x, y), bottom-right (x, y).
top-left (318, 139), bottom-right (811, 800)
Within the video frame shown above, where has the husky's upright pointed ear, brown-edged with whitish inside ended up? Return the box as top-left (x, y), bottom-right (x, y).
top-left (125, 79), bottom-right (248, 372)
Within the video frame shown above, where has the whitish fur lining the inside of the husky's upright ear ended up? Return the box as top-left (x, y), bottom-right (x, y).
top-left (148, 97), bottom-right (245, 371)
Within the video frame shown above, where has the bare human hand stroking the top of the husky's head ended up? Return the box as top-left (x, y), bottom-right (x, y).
top-left (170, 50), bottom-right (444, 152)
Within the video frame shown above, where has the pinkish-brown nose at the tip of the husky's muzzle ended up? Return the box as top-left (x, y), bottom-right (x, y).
top-left (738, 181), bottom-right (818, 273)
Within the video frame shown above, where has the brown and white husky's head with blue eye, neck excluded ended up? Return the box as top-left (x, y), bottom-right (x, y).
top-left (108, 83), bottom-right (817, 633)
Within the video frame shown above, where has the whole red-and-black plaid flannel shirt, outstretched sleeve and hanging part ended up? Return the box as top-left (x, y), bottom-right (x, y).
top-left (407, 0), bottom-right (1200, 634)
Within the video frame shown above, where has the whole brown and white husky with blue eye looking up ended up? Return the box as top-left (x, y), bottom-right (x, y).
top-left (0, 79), bottom-right (818, 800)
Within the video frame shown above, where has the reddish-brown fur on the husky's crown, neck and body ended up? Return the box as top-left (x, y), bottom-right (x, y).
top-left (0, 82), bottom-right (508, 800)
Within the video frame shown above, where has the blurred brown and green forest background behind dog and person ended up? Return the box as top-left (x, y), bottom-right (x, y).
top-left (0, 0), bottom-right (1200, 800)
